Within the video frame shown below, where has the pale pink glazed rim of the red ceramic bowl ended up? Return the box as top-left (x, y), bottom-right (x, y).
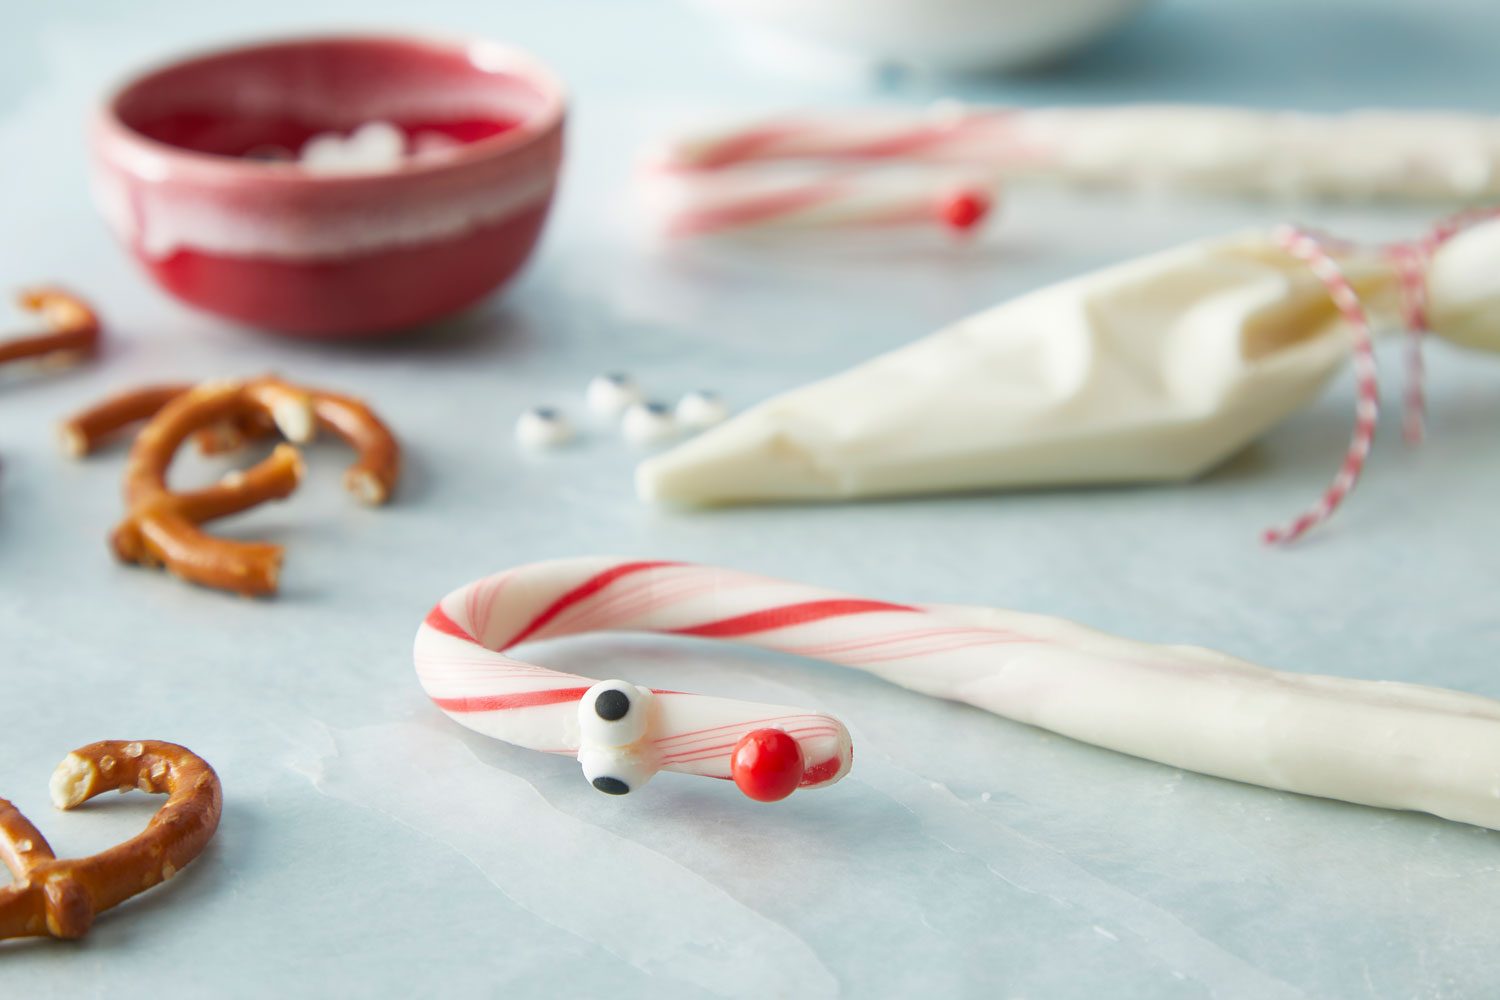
top-left (95, 31), bottom-right (569, 186)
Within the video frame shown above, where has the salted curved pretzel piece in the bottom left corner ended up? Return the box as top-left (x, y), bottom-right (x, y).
top-left (0, 739), bottom-right (224, 939)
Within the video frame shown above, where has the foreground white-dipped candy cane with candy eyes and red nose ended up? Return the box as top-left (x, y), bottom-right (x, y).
top-left (416, 558), bottom-right (1500, 829)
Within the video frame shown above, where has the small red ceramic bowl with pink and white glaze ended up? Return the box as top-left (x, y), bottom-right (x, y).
top-left (93, 37), bottom-right (564, 336)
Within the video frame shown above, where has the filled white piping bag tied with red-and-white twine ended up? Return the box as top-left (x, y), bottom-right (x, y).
top-left (636, 222), bottom-right (1500, 505)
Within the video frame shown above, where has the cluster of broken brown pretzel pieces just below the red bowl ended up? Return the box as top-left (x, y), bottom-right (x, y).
top-left (62, 376), bottom-right (401, 595)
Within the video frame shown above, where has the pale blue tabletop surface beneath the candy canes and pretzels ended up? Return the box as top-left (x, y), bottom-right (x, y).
top-left (0, 0), bottom-right (1500, 999)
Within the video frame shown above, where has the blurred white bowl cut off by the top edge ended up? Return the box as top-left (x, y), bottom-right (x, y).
top-left (698, 0), bottom-right (1146, 72)
